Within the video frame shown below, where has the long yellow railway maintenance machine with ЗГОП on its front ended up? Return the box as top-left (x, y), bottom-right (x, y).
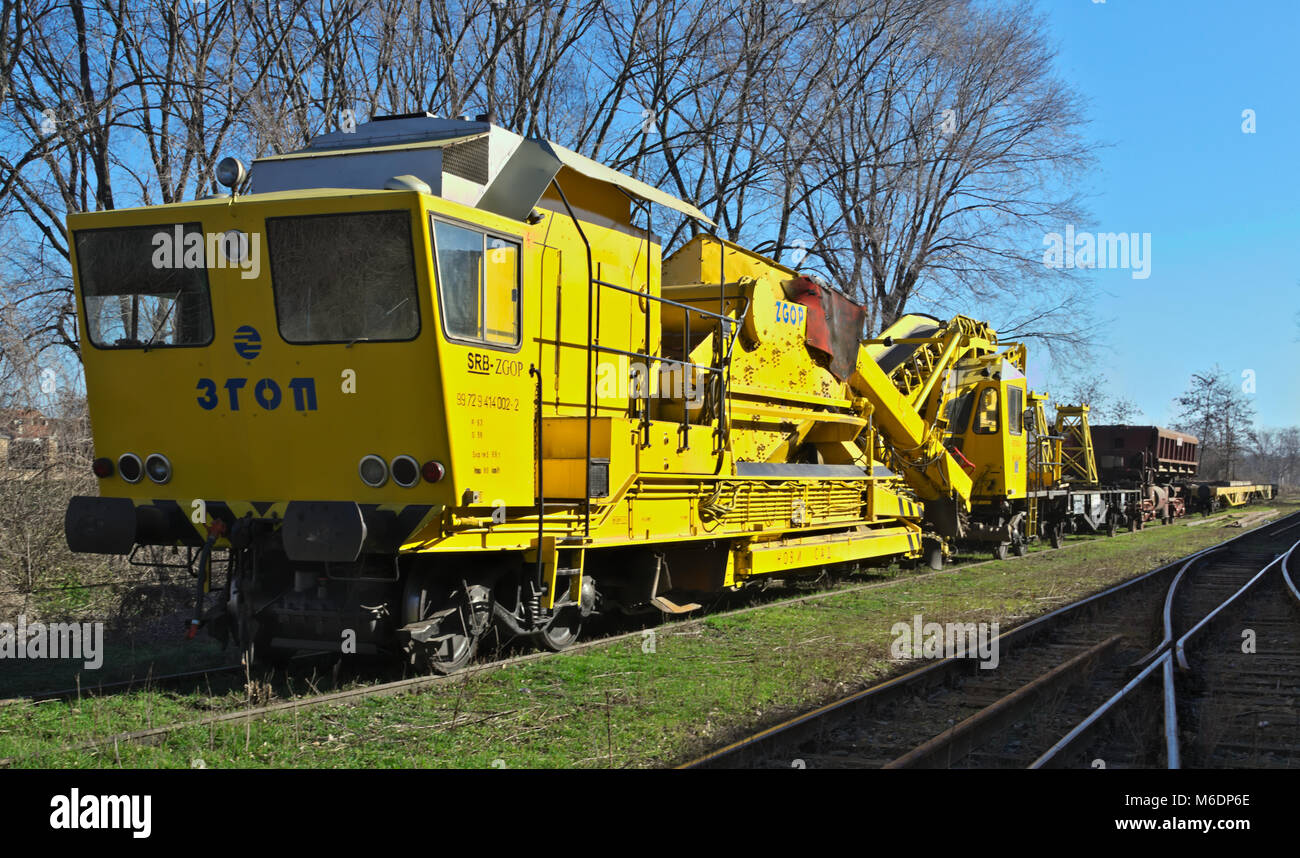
top-left (66, 116), bottom-right (1024, 671)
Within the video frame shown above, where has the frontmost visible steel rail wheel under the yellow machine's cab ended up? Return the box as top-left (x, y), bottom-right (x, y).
top-left (402, 575), bottom-right (491, 673)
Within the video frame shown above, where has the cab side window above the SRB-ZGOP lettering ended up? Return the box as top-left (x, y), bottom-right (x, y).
top-left (433, 220), bottom-right (520, 347)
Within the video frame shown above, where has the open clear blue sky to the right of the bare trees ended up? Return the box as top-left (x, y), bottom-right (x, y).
top-left (1030, 0), bottom-right (1300, 426)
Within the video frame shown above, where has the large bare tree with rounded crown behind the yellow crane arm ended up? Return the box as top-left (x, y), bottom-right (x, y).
top-left (803, 3), bottom-right (1091, 346)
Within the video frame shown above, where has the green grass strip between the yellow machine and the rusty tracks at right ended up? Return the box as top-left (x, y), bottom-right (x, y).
top-left (0, 504), bottom-right (1300, 768)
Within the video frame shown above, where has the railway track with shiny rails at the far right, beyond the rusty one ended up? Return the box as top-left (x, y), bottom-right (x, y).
top-left (1034, 520), bottom-right (1300, 768)
